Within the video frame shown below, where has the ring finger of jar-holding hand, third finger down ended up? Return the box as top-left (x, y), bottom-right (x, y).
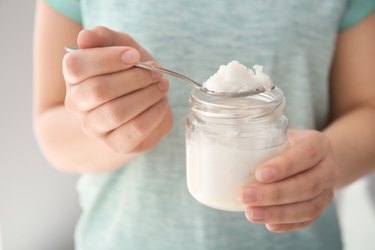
top-left (245, 189), bottom-right (333, 224)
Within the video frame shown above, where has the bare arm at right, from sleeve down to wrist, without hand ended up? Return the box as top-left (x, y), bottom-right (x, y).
top-left (324, 10), bottom-right (375, 188)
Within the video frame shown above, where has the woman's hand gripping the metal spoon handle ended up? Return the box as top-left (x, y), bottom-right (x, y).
top-left (63, 27), bottom-right (172, 154)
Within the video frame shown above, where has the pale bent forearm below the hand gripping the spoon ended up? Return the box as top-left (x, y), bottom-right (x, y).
top-left (34, 106), bottom-right (135, 173)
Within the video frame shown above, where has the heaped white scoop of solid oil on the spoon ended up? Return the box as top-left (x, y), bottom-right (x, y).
top-left (203, 61), bottom-right (274, 93)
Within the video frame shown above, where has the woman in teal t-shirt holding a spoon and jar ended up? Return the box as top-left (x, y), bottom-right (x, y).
top-left (35, 0), bottom-right (375, 250)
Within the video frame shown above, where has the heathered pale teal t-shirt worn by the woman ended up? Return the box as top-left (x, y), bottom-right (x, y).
top-left (46, 0), bottom-right (375, 250)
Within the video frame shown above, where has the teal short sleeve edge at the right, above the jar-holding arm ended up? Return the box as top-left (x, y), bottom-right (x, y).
top-left (339, 0), bottom-right (375, 31)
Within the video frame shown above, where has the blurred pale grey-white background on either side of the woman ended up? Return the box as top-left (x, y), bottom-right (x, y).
top-left (0, 0), bottom-right (375, 250)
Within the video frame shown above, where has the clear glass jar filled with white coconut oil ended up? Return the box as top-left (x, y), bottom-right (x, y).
top-left (186, 87), bottom-right (288, 211)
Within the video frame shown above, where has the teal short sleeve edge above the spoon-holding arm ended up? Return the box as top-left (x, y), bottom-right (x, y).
top-left (44, 0), bottom-right (82, 23)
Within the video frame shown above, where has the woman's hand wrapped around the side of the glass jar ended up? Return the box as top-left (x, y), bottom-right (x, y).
top-left (242, 130), bottom-right (339, 232)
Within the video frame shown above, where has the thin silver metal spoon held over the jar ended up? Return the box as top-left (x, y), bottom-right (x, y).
top-left (64, 47), bottom-right (274, 98)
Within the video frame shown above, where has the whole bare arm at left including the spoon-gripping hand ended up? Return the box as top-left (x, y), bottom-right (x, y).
top-left (34, 0), bottom-right (171, 172)
